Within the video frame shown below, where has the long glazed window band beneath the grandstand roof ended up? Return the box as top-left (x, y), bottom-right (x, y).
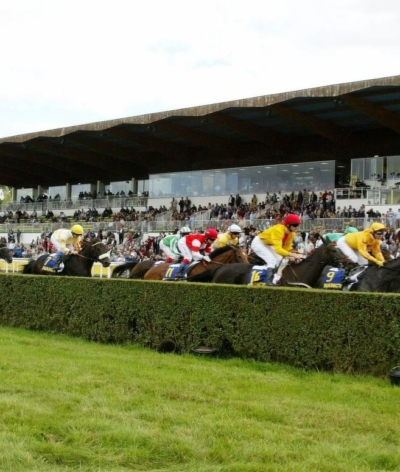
top-left (149, 161), bottom-right (336, 198)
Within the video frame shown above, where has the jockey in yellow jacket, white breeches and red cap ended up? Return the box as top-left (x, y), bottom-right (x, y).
top-left (251, 213), bottom-right (302, 286)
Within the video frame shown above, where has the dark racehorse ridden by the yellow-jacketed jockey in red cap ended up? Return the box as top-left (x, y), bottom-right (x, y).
top-left (192, 241), bottom-right (353, 288)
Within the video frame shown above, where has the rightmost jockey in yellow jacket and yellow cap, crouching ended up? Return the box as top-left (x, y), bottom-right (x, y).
top-left (337, 223), bottom-right (386, 266)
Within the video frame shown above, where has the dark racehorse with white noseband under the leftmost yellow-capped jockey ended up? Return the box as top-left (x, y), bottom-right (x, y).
top-left (22, 238), bottom-right (111, 277)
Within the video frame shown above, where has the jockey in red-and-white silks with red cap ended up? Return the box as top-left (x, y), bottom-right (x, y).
top-left (176, 228), bottom-right (218, 277)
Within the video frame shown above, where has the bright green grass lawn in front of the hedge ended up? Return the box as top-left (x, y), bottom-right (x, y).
top-left (0, 327), bottom-right (400, 472)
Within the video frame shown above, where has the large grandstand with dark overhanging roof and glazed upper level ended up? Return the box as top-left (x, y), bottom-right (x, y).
top-left (0, 76), bottom-right (400, 245)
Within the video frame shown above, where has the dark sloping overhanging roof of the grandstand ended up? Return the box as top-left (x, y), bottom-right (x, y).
top-left (0, 76), bottom-right (400, 188)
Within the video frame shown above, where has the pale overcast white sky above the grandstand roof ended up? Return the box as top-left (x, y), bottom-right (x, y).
top-left (0, 0), bottom-right (400, 138)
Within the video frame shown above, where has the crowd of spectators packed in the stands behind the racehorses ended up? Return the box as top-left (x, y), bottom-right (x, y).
top-left (0, 189), bottom-right (400, 262)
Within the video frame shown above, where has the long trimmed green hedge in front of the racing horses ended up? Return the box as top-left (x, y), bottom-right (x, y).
top-left (0, 274), bottom-right (400, 375)
